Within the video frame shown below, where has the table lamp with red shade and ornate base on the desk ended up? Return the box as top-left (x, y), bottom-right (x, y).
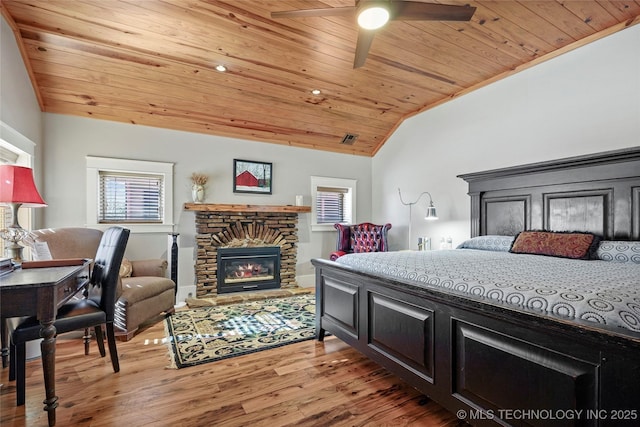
top-left (0, 165), bottom-right (47, 264)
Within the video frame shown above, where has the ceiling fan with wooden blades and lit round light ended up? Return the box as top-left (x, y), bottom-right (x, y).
top-left (271, 0), bottom-right (476, 68)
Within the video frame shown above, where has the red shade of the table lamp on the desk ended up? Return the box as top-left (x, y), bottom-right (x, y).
top-left (0, 165), bottom-right (47, 207)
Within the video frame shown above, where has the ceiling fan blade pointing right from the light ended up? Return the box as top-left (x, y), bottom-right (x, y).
top-left (391, 1), bottom-right (476, 21)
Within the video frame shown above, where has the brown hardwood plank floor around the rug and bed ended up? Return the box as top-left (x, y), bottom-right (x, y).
top-left (0, 318), bottom-right (465, 427)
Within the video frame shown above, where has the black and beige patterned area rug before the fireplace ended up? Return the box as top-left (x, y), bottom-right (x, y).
top-left (166, 294), bottom-right (315, 368)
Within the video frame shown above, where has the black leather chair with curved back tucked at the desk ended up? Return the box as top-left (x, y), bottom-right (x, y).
top-left (9, 227), bottom-right (129, 406)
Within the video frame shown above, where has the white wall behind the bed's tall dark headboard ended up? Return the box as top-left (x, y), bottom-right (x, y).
top-left (372, 25), bottom-right (640, 249)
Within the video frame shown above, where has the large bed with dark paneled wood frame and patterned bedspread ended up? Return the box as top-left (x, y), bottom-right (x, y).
top-left (312, 147), bottom-right (640, 426)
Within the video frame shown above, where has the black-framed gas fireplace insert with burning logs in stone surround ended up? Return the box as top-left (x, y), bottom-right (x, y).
top-left (217, 246), bottom-right (280, 294)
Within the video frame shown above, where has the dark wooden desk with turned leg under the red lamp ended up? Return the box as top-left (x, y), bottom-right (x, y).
top-left (0, 260), bottom-right (90, 426)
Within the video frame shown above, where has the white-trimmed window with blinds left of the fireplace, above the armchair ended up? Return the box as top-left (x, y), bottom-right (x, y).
top-left (87, 156), bottom-right (173, 232)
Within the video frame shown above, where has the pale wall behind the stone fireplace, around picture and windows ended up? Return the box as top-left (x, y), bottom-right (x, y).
top-left (44, 113), bottom-right (371, 298)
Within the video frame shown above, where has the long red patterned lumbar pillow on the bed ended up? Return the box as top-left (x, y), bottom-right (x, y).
top-left (509, 231), bottom-right (600, 259)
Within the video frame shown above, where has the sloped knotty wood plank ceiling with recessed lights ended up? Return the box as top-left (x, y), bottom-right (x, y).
top-left (1, 0), bottom-right (640, 156)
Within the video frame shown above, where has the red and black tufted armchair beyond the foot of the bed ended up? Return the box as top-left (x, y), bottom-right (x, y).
top-left (329, 222), bottom-right (391, 261)
